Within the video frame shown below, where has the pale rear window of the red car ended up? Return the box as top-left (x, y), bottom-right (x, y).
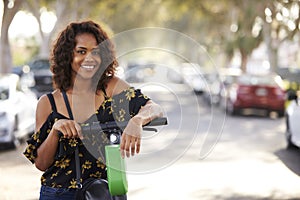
top-left (238, 76), bottom-right (282, 86)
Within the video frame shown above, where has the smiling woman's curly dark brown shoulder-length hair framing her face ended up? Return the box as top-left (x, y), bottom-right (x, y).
top-left (50, 20), bottom-right (118, 92)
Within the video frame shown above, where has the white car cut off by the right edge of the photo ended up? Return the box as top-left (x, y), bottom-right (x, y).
top-left (286, 92), bottom-right (300, 148)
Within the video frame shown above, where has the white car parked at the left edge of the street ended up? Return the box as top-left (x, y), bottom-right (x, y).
top-left (0, 74), bottom-right (37, 148)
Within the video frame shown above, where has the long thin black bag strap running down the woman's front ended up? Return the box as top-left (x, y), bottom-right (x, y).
top-left (62, 91), bottom-right (82, 189)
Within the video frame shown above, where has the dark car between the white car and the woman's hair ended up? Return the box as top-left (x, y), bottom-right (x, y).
top-left (24, 58), bottom-right (53, 98)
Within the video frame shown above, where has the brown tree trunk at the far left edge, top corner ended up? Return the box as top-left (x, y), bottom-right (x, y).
top-left (0, 0), bottom-right (23, 73)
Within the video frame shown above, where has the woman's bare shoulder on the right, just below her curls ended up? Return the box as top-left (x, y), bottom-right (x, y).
top-left (106, 76), bottom-right (130, 96)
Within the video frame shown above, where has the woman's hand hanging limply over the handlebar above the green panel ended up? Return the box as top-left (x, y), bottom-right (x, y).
top-left (120, 117), bottom-right (143, 158)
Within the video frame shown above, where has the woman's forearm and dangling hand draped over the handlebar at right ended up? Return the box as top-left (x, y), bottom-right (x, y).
top-left (120, 100), bottom-right (163, 158)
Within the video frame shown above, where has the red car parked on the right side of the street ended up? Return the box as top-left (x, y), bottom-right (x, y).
top-left (222, 74), bottom-right (286, 117)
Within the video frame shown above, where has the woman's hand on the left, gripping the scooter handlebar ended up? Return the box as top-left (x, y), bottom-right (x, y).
top-left (52, 119), bottom-right (83, 139)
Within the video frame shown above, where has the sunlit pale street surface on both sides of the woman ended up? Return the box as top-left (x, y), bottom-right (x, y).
top-left (0, 87), bottom-right (300, 200)
